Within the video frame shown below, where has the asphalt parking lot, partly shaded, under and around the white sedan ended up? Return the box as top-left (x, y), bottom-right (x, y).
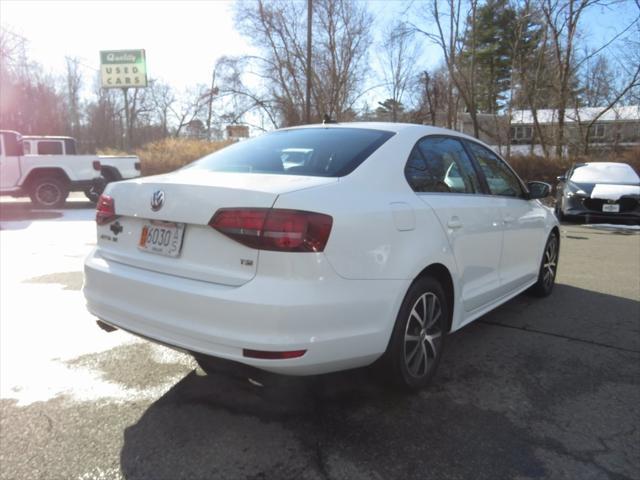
top-left (0, 196), bottom-right (640, 480)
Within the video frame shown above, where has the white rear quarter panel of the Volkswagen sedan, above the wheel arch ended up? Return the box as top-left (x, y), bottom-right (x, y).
top-left (274, 127), bottom-right (458, 328)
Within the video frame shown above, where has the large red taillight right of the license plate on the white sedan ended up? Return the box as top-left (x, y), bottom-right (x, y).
top-left (209, 208), bottom-right (333, 252)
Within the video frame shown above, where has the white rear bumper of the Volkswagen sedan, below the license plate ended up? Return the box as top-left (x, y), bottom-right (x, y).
top-left (84, 251), bottom-right (408, 375)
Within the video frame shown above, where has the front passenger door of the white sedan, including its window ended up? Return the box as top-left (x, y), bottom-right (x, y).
top-left (466, 141), bottom-right (546, 295)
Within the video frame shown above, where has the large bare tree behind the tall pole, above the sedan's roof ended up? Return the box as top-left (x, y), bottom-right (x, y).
top-left (236, 0), bottom-right (372, 125)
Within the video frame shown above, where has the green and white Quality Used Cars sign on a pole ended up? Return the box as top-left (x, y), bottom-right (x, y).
top-left (100, 50), bottom-right (147, 88)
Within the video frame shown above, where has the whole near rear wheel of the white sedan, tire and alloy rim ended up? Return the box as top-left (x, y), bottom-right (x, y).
top-left (381, 276), bottom-right (450, 391)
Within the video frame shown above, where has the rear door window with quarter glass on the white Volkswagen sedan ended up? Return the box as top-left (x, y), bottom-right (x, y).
top-left (404, 137), bottom-right (480, 193)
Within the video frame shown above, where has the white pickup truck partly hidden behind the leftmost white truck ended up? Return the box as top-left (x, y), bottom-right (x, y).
top-left (22, 135), bottom-right (140, 202)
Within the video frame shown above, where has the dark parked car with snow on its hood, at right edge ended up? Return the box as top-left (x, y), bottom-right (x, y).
top-left (555, 162), bottom-right (640, 223)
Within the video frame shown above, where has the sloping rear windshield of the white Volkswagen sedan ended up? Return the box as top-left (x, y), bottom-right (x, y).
top-left (186, 127), bottom-right (394, 177)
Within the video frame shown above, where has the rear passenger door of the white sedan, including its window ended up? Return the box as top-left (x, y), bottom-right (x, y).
top-left (405, 136), bottom-right (502, 312)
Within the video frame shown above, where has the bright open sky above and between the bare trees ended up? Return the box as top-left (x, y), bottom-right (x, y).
top-left (0, 0), bottom-right (638, 99)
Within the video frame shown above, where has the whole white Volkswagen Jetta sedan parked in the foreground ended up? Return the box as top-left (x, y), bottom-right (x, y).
top-left (84, 123), bottom-right (560, 388)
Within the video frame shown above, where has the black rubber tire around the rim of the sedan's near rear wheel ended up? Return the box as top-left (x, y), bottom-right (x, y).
top-left (385, 276), bottom-right (450, 390)
